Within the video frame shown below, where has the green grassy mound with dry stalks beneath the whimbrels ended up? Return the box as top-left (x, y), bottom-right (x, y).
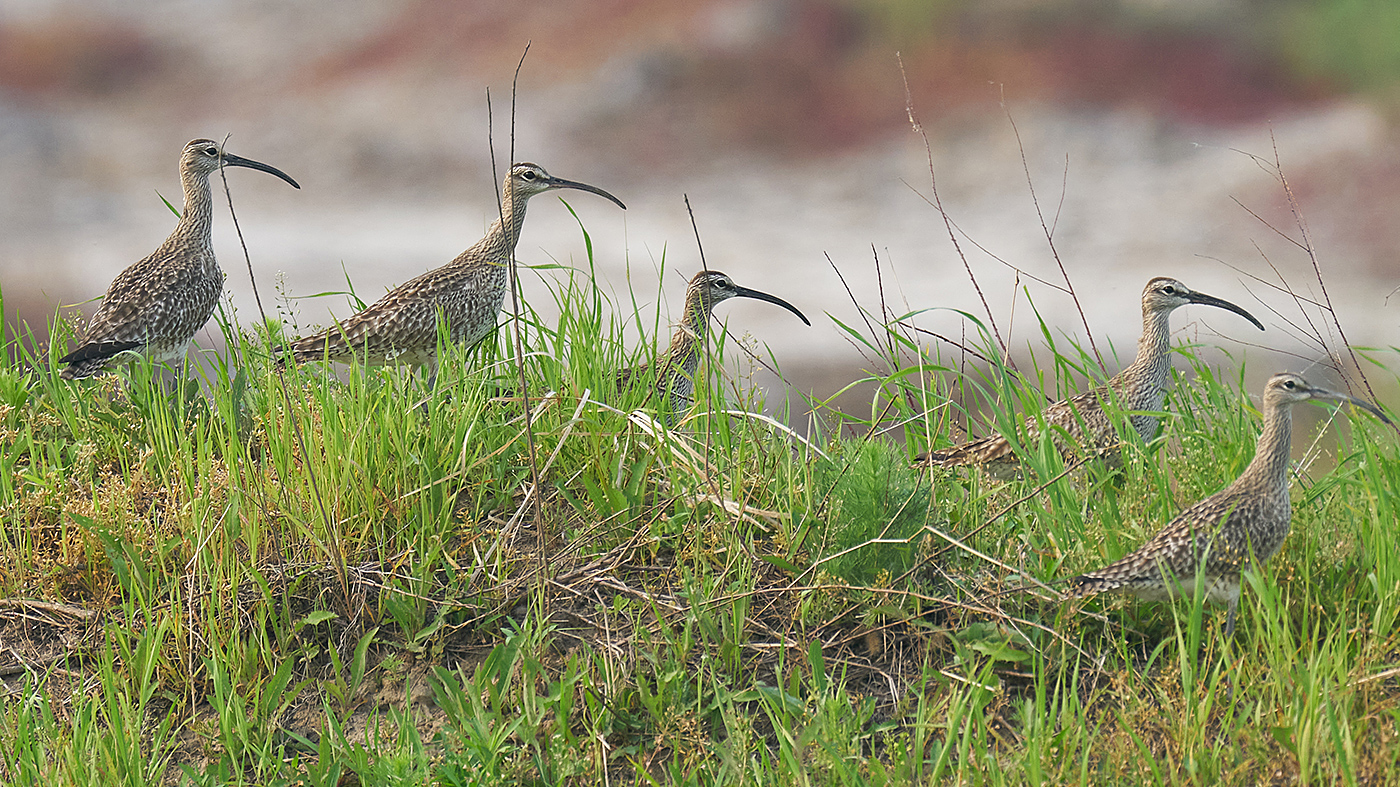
top-left (0, 252), bottom-right (1400, 786)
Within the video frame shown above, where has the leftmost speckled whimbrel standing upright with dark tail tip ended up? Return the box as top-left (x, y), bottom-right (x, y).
top-left (59, 140), bottom-right (301, 379)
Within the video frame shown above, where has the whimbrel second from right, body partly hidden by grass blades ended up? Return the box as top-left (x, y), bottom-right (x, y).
top-left (914, 276), bottom-right (1264, 476)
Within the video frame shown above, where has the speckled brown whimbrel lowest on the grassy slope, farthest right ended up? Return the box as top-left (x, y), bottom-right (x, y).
top-left (1070, 372), bottom-right (1390, 636)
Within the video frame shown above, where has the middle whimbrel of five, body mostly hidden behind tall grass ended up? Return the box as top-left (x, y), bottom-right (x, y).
top-left (617, 270), bottom-right (812, 423)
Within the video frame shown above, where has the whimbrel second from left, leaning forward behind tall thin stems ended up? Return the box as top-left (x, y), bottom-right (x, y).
top-left (279, 162), bottom-right (627, 388)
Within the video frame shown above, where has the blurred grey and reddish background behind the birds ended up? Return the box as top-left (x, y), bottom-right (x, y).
top-left (0, 0), bottom-right (1400, 417)
